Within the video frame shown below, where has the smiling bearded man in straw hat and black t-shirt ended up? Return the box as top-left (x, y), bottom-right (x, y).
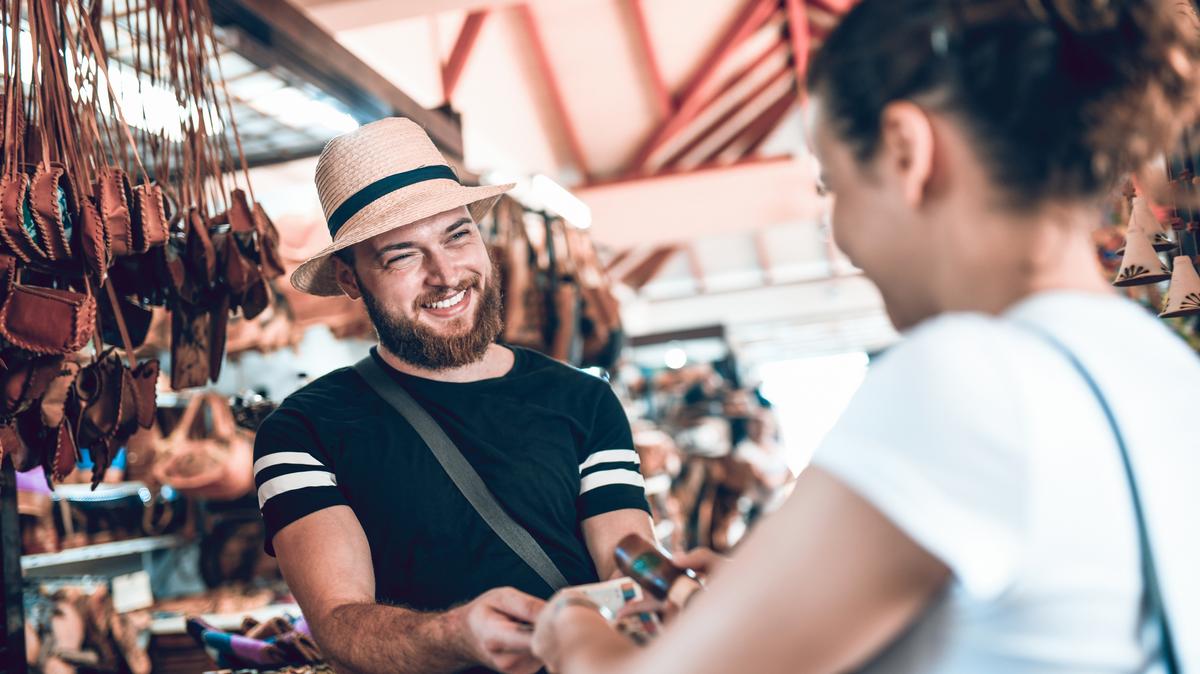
top-left (254, 119), bottom-right (652, 673)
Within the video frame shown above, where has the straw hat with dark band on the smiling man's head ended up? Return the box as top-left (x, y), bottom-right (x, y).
top-left (292, 118), bottom-right (512, 295)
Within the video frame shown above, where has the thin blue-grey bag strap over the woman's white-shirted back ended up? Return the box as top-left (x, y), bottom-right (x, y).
top-left (1019, 323), bottom-right (1180, 674)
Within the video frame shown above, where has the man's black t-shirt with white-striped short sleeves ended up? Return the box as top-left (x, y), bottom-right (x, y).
top-left (254, 348), bottom-right (649, 610)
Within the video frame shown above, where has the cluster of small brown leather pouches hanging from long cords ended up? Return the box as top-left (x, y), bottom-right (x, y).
top-left (0, 0), bottom-right (283, 483)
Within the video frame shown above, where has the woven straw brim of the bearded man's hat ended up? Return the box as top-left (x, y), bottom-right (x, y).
top-left (292, 180), bottom-right (514, 296)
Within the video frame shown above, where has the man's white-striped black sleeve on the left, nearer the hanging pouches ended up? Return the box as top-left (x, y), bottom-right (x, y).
top-left (254, 408), bottom-right (347, 556)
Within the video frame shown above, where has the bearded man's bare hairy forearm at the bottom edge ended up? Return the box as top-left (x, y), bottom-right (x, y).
top-left (313, 603), bottom-right (474, 674)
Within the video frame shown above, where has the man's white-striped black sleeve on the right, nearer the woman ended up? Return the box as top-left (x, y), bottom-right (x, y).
top-left (577, 386), bottom-right (650, 520)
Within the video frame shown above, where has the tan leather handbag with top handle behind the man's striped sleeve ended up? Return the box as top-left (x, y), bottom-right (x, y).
top-left (154, 392), bottom-right (254, 500)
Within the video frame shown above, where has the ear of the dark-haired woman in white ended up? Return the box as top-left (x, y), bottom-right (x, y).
top-left (875, 101), bottom-right (934, 209)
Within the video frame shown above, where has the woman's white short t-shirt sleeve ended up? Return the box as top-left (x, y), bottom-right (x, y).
top-left (814, 315), bottom-right (1030, 600)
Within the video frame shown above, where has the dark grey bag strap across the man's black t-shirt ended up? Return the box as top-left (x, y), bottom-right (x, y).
top-left (354, 356), bottom-right (568, 591)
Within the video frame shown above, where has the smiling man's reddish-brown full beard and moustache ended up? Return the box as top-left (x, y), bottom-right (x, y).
top-left (359, 273), bottom-right (503, 372)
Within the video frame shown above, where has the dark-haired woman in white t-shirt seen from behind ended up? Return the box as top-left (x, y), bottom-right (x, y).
top-left (535, 0), bottom-right (1200, 674)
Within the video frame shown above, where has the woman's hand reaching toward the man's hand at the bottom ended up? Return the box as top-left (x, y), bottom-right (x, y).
top-left (533, 589), bottom-right (624, 673)
